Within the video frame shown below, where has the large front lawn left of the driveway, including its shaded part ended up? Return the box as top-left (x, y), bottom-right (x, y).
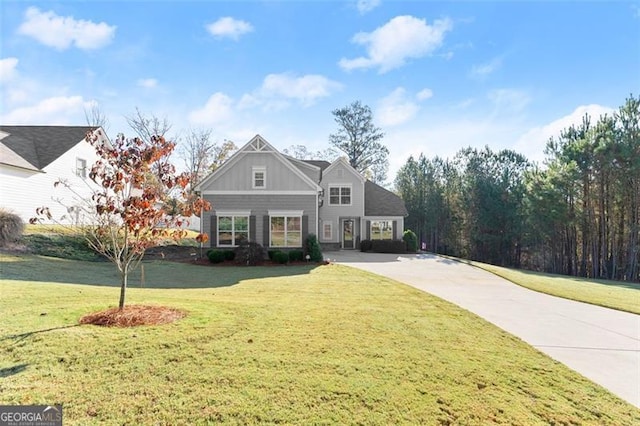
top-left (0, 254), bottom-right (640, 425)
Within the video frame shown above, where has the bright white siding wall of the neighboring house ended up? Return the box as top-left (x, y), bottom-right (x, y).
top-left (0, 141), bottom-right (98, 223)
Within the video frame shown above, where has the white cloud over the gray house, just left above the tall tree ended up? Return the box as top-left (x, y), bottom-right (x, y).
top-left (258, 73), bottom-right (342, 106)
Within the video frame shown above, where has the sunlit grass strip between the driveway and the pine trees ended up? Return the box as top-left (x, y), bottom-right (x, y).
top-left (451, 258), bottom-right (640, 314)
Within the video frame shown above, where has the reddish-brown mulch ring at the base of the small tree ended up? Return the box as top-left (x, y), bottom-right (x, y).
top-left (80, 305), bottom-right (186, 327)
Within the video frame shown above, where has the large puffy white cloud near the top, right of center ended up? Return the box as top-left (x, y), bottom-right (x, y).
top-left (339, 15), bottom-right (453, 73)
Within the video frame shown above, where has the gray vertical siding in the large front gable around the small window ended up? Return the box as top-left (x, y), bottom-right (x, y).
top-left (209, 152), bottom-right (313, 193)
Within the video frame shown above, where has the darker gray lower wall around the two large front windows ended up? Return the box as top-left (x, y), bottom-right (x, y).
top-left (202, 193), bottom-right (318, 247)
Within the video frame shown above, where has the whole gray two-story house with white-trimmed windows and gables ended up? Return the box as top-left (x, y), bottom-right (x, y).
top-left (196, 135), bottom-right (407, 249)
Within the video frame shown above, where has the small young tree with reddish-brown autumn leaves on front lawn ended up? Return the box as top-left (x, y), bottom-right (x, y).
top-left (31, 131), bottom-right (209, 309)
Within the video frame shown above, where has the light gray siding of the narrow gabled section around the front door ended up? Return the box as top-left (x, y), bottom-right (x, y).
top-left (318, 164), bottom-right (364, 243)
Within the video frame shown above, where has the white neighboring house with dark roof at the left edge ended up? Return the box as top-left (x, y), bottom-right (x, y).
top-left (0, 125), bottom-right (110, 224)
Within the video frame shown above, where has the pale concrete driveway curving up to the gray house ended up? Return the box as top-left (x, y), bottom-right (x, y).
top-left (325, 251), bottom-right (640, 407)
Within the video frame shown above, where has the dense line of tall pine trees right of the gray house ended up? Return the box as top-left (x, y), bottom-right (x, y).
top-left (395, 95), bottom-right (640, 282)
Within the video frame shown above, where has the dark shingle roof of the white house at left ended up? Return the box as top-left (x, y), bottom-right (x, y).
top-left (0, 126), bottom-right (94, 170)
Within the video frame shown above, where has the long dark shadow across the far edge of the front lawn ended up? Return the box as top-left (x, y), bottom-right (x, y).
top-left (0, 256), bottom-right (319, 289)
